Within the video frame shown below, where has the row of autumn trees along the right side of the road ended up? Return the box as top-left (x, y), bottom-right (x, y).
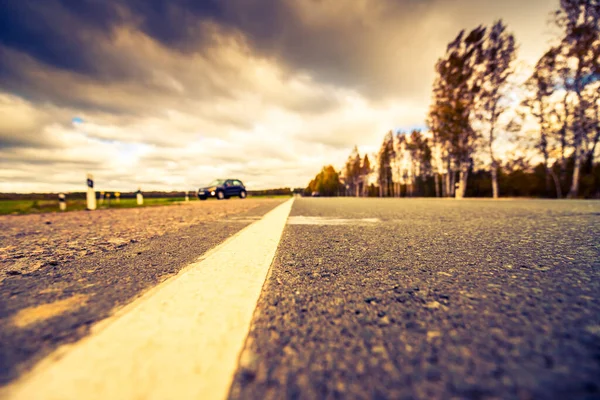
top-left (306, 0), bottom-right (600, 198)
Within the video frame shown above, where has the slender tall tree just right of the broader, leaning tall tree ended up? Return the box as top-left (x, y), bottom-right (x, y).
top-left (475, 20), bottom-right (516, 199)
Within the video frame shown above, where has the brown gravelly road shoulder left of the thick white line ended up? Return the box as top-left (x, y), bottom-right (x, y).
top-left (0, 199), bottom-right (283, 383)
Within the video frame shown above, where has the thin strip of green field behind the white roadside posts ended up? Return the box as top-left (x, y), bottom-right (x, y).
top-left (0, 196), bottom-right (290, 215)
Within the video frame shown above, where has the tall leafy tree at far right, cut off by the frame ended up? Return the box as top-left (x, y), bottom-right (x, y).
top-left (523, 0), bottom-right (600, 198)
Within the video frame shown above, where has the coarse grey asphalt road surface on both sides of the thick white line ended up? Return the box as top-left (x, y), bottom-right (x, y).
top-left (0, 198), bottom-right (600, 399)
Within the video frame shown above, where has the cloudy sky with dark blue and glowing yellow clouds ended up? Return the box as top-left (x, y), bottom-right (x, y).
top-left (0, 0), bottom-right (558, 192)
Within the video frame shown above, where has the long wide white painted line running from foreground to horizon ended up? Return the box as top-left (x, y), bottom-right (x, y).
top-left (3, 199), bottom-right (293, 400)
